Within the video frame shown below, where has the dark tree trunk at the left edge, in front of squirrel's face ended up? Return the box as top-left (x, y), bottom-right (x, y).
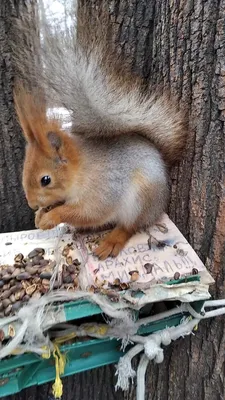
top-left (0, 0), bottom-right (35, 232)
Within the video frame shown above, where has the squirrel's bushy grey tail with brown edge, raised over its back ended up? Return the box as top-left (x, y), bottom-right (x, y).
top-left (13, 0), bottom-right (187, 162)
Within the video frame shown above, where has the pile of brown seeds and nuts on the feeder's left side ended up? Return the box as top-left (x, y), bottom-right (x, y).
top-left (0, 244), bottom-right (80, 318)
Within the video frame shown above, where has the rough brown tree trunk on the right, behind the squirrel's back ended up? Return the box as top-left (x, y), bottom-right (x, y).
top-left (147, 0), bottom-right (225, 400)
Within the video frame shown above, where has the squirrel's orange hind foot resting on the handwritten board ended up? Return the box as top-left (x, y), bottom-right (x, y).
top-left (94, 226), bottom-right (134, 260)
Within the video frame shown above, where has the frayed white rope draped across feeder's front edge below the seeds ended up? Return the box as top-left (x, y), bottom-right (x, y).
top-left (0, 290), bottom-right (137, 359)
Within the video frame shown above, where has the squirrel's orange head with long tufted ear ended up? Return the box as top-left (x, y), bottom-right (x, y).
top-left (15, 88), bottom-right (80, 209)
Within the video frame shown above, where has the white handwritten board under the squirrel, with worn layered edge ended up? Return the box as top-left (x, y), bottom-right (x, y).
top-left (0, 214), bottom-right (214, 306)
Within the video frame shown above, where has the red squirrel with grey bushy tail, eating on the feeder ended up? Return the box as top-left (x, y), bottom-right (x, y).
top-left (15, 0), bottom-right (187, 259)
